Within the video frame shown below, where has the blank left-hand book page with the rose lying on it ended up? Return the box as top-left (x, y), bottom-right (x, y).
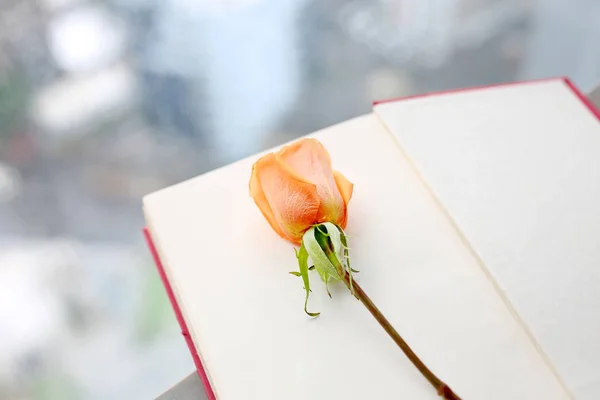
top-left (144, 115), bottom-right (568, 400)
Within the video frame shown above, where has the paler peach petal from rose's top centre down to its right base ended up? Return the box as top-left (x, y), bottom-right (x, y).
top-left (275, 139), bottom-right (346, 223)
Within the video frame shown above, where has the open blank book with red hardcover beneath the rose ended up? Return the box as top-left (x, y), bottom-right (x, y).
top-left (144, 79), bottom-right (600, 400)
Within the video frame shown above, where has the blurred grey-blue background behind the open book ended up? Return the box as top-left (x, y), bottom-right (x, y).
top-left (0, 0), bottom-right (600, 400)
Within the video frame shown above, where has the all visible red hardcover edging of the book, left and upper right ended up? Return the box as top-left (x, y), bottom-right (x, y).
top-left (144, 77), bottom-right (600, 400)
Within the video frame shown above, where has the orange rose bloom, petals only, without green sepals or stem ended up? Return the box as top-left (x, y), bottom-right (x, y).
top-left (250, 139), bottom-right (353, 244)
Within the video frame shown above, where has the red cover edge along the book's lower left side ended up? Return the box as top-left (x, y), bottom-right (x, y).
top-left (144, 228), bottom-right (217, 400)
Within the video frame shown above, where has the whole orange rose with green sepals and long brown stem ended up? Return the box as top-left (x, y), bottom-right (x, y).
top-left (250, 139), bottom-right (460, 400)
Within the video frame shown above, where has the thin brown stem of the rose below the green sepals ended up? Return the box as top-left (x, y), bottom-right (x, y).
top-left (338, 274), bottom-right (460, 400)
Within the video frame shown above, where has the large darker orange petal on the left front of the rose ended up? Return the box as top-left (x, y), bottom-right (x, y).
top-left (255, 154), bottom-right (320, 244)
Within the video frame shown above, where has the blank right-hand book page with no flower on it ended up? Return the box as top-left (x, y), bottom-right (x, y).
top-left (375, 80), bottom-right (600, 400)
